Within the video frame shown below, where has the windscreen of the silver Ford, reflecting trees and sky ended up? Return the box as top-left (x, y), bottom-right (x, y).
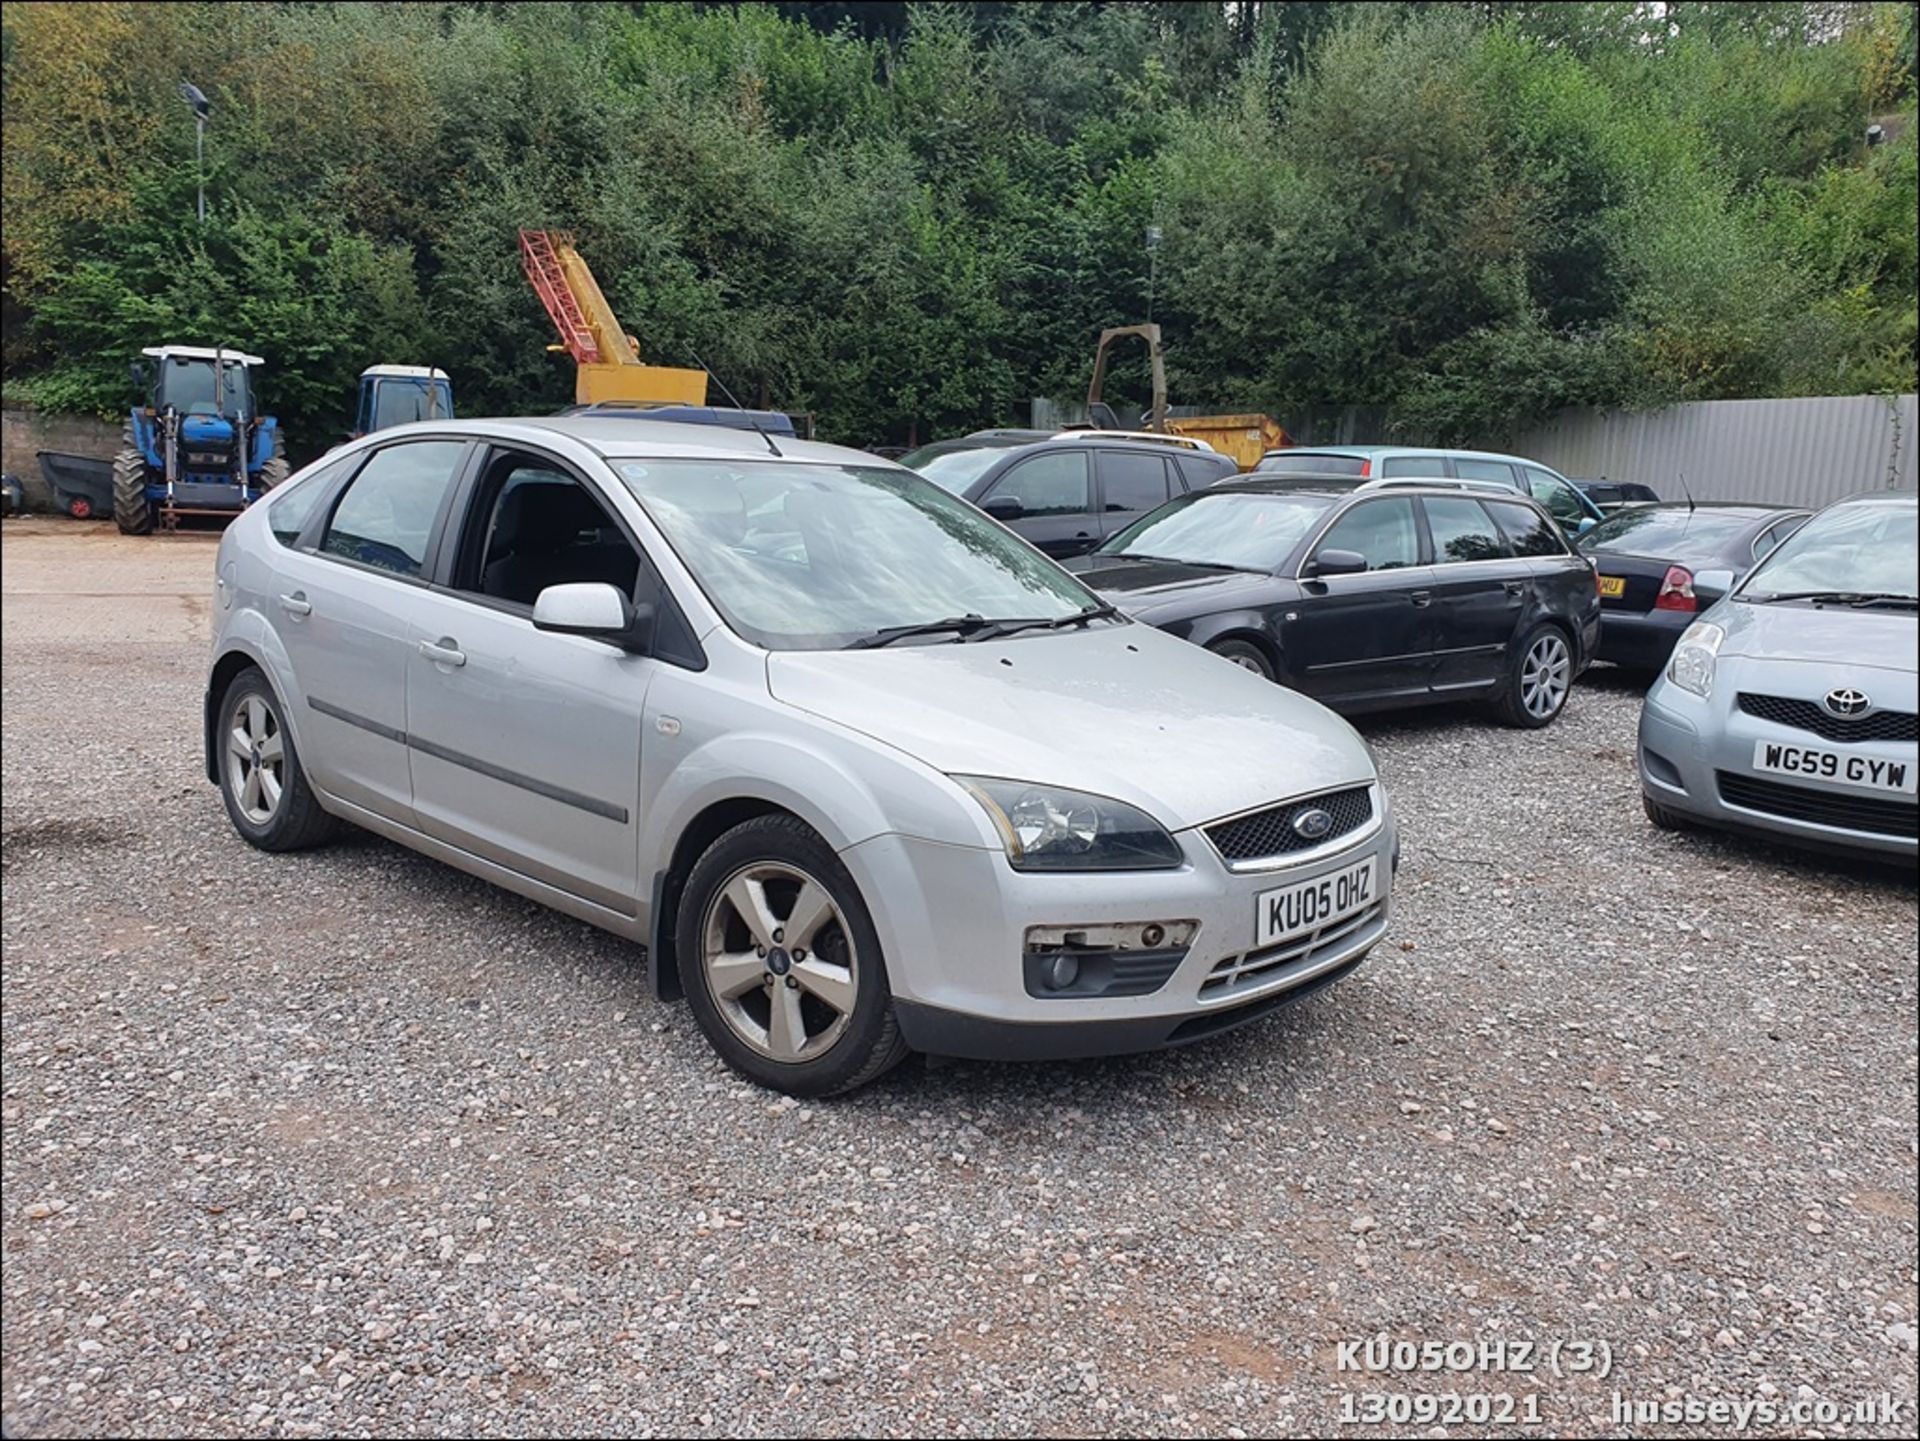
top-left (612, 459), bottom-right (1098, 650)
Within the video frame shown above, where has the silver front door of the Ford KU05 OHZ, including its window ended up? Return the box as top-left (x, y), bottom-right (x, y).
top-left (407, 451), bottom-right (659, 915)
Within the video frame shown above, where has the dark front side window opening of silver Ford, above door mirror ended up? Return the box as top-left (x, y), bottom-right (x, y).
top-left (461, 453), bottom-right (639, 606)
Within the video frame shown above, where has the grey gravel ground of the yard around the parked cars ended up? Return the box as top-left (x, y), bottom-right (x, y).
top-left (0, 522), bottom-right (1916, 1437)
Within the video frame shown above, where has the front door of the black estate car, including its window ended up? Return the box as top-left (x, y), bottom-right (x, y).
top-left (1279, 495), bottom-right (1434, 706)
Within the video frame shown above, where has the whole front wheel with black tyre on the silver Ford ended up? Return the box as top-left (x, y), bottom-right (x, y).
top-left (676, 815), bottom-right (906, 1096)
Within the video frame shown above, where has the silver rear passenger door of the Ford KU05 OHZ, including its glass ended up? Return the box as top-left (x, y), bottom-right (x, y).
top-left (267, 439), bottom-right (468, 825)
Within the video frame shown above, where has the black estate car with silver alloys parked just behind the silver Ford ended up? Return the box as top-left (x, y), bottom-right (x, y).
top-left (1068, 476), bottom-right (1599, 727)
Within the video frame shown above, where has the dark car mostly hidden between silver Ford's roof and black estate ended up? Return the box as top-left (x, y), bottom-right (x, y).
top-left (900, 430), bottom-right (1238, 558)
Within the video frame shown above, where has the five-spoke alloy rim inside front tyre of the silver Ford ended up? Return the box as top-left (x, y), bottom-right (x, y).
top-left (701, 862), bottom-right (860, 1063)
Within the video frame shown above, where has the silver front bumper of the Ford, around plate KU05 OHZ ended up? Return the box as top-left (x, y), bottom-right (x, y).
top-left (841, 791), bottom-right (1400, 1059)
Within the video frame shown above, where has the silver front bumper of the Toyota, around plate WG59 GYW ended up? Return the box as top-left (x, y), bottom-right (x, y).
top-left (1638, 666), bottom-right (1920, 860)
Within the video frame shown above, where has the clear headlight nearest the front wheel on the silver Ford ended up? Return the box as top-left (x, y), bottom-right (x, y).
top-left (954, 775), bottom-right (1185, 871)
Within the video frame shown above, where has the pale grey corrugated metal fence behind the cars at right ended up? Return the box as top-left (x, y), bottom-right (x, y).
top-left (1488, 395), bottom-right (1920, 507)
